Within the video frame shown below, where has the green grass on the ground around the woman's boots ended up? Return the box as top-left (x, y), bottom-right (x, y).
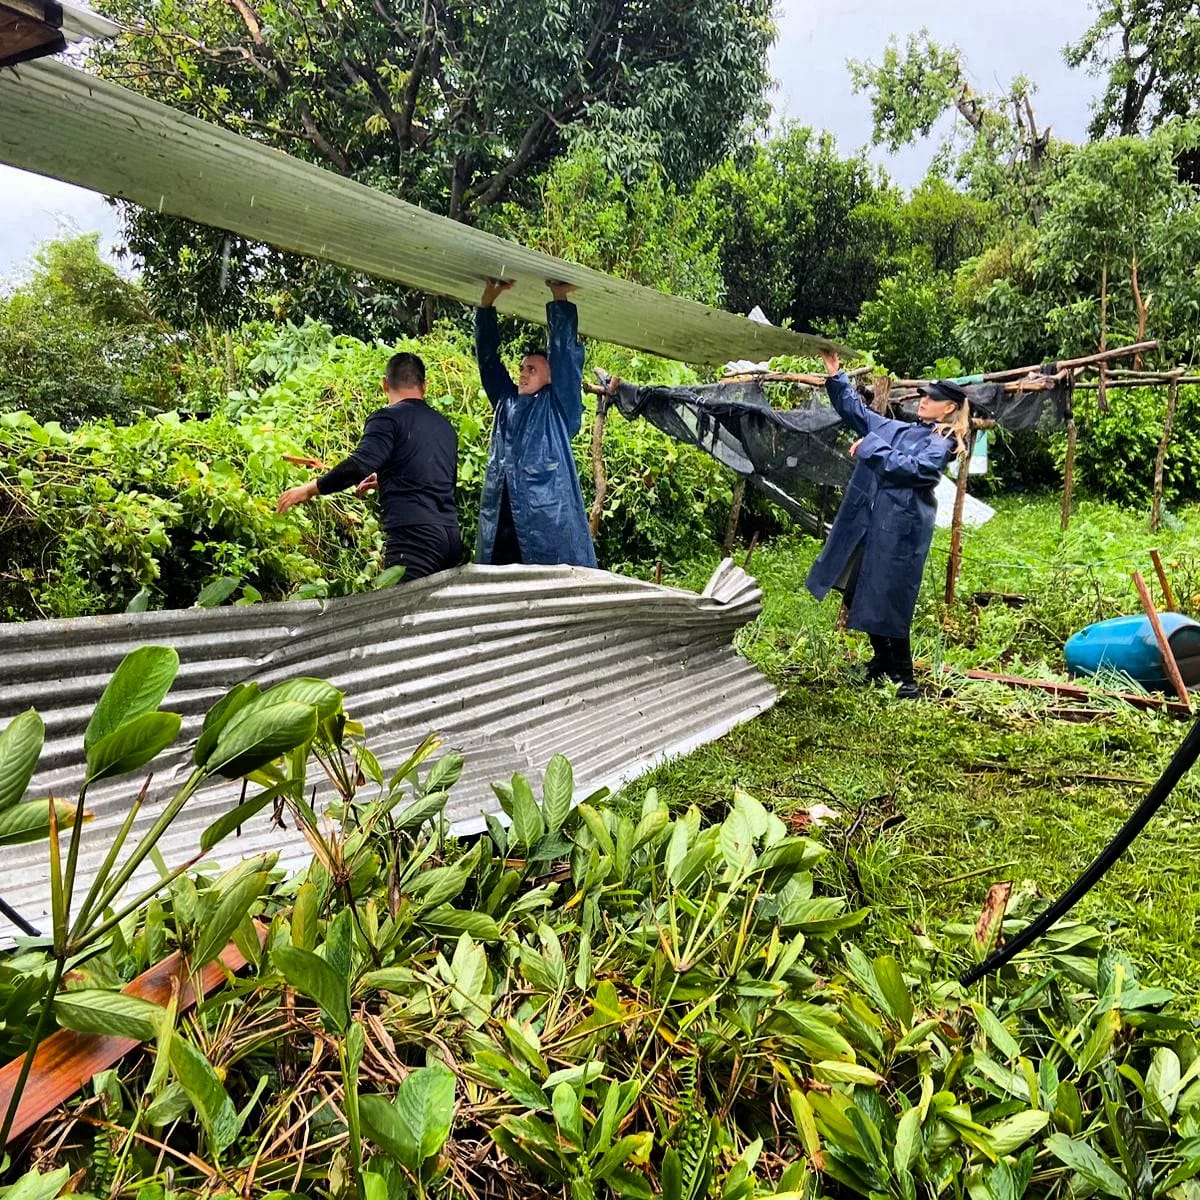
top-left (634, 497), bottom-right (1200, 1007)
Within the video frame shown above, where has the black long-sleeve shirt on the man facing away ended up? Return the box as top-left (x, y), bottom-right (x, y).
top-left (317, 400), bottom-right (458, 530)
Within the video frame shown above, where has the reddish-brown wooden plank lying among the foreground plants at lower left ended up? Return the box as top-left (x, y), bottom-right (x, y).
top-left (0, 925), bottom-right (255, 1144)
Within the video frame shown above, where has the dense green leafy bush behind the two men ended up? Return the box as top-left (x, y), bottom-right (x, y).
top-left (0, 323), bottom-right (732, 620)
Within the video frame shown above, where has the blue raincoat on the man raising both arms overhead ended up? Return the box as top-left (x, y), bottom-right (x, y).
top-left (475, 300), bottom-right (596, 566)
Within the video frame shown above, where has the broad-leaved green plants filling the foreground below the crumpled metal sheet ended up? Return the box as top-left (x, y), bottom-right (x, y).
top-left (0, 710), bottom-right (1200, 1200)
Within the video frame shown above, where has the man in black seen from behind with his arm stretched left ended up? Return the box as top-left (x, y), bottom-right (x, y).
top-left (276, 354), bottom-right (462, 583)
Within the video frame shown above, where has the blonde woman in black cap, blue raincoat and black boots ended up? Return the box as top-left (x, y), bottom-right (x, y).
top-left (805, 354), bottom-right (971, 700)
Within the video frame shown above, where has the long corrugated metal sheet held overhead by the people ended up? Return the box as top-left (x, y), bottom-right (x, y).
top-left (0, 60), bottom-right (833, 364)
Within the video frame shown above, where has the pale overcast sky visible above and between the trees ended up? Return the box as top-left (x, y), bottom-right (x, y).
top-left (0, 0), bottom-right (1097, 275)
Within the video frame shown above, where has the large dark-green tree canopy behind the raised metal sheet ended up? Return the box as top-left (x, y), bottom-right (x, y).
top-left (91, 0), bottom-right (775, 324)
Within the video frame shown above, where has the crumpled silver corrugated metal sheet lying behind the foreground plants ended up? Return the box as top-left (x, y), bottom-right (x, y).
top-left (0, 560), bottom-right (776, 932)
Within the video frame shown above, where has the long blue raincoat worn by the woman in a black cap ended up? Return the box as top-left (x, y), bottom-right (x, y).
top-left (805, 371), bottom-right (953, 637)
